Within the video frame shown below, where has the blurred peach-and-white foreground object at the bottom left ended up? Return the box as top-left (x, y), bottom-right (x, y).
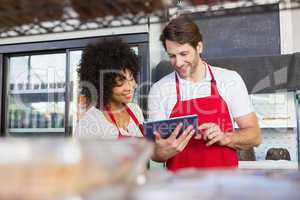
top-left (0, 138), bottom-right (152, 200)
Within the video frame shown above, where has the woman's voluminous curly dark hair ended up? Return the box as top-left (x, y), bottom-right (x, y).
top-left (77, 38), bottom-right (139, 108)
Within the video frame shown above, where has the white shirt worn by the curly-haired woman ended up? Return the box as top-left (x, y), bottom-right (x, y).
top-left (74, 103), bottom-right (144, 139)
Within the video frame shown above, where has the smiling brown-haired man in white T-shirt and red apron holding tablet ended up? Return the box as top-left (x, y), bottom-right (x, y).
top-left (148, 16), bottom-right (261, 171)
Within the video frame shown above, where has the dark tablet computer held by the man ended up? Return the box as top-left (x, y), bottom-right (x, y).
top-left (143, 115), bottom-right (198, 141)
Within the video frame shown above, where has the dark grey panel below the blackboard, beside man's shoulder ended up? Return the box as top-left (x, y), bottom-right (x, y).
top-left (206, 54), bottom-right (300, 94)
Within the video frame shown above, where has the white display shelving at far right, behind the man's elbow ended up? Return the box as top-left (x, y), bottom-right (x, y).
top-left (245, 90), bottom-right (299, 166)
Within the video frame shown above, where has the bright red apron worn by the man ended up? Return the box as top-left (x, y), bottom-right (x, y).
top-left (167, 65), bottom-right (238, 171)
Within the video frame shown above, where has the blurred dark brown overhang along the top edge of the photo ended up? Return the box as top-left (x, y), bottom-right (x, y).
top-left (0, 0), bottom-right (300, 38)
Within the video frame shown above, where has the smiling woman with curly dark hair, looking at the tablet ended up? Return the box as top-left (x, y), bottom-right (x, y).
top-left (74, 39), bottom-right (144, 139)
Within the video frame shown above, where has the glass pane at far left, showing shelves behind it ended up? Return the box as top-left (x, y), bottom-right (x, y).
top-left (7, 53), bottom-right (66, 135)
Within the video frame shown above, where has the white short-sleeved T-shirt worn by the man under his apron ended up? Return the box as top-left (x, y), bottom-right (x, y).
top-left (148, 65), bottom-right (253, 121)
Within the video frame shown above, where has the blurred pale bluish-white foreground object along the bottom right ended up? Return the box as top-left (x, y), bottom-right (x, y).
top-left (133, 169), bottom-right (300, 200)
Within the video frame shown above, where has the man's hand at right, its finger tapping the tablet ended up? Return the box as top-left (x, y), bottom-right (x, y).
top-left (195, 123), bottom-right (230, 146)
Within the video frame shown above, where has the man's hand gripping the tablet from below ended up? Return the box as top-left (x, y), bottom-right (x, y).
top-left (152, 124), bottom-right (195, 162)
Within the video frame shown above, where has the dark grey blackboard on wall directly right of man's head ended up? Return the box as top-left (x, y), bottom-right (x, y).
top-left (192, 4), bottom-right (280, 58)
